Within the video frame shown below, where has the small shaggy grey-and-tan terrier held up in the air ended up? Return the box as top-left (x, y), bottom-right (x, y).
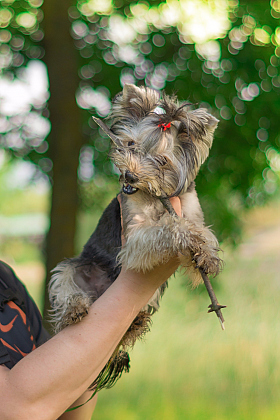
top-left (49, 84), bottom-right (221, 390)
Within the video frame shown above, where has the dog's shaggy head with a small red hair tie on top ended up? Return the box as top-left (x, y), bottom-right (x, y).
top-left (94, 85), bottom-right (218, 197)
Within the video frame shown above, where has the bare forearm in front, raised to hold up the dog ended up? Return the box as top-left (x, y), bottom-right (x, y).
top-left (0, 262), bottom-right (176, 420)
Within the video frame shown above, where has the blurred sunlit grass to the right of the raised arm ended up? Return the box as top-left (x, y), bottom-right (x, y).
top-left (93, 226), bottom-right (280, 420)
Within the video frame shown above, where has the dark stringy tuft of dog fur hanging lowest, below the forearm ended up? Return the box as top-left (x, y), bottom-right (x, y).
top-left (89, 350), bottom-right (130, 392)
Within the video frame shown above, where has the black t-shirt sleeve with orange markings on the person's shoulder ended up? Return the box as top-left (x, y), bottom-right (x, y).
top-left (0, 261), bottom-right (50, 369)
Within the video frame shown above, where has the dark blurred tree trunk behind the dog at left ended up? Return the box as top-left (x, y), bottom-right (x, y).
top-left (43, 0), bottom-right (82, 330)
